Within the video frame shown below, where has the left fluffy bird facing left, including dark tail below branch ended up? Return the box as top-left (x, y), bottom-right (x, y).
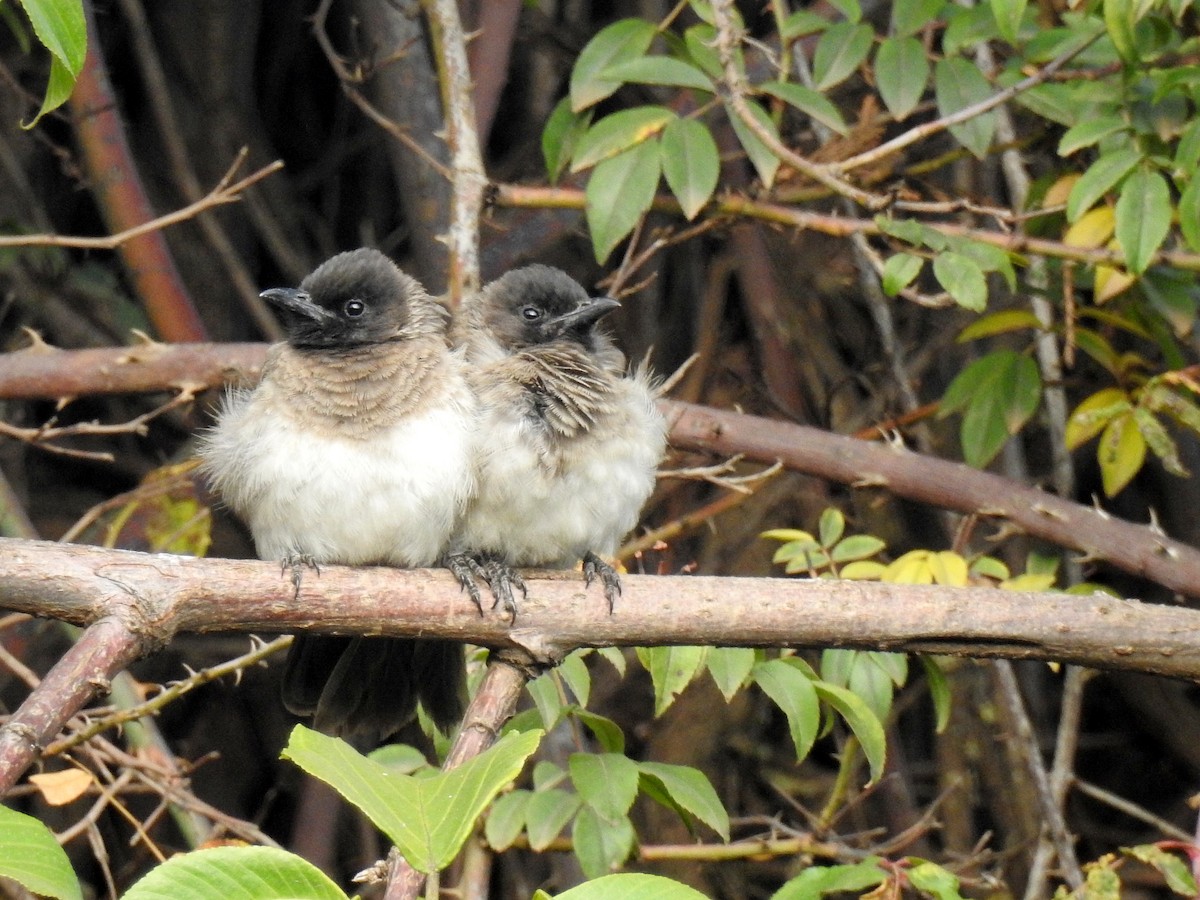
top-left (199, 247), bottom-right (476, 742)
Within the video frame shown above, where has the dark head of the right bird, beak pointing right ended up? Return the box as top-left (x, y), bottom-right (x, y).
top-left (484, 265), bottom-right (620, 352)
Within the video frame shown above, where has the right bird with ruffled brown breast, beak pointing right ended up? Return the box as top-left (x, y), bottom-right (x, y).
top-left (449, 264), bottom-right (666, 620)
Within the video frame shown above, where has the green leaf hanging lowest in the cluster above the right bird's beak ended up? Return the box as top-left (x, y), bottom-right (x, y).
top-left (584, 142), bottom-right (659, 263)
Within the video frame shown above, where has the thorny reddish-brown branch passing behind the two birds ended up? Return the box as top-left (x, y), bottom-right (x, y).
top-left (0, 344), bottom-right (1200, 598)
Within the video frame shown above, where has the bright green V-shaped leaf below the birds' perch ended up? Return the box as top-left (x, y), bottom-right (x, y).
top-left (282, 725), bottom-right (542, 872)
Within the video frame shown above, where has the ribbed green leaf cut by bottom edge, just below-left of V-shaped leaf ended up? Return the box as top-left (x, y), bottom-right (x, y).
top-left (124, 847), bottom-right (346, 900)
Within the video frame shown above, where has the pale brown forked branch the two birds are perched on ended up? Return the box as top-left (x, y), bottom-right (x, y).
top-left (0, 539), bottom-right (1200, 790)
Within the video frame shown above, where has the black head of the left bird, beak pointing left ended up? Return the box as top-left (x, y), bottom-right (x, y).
top-left (262, 247), bottom-right (445, 349)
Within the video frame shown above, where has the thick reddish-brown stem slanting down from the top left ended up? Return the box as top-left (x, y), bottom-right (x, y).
top-left (68, 2), bottom-right (205, 341)
